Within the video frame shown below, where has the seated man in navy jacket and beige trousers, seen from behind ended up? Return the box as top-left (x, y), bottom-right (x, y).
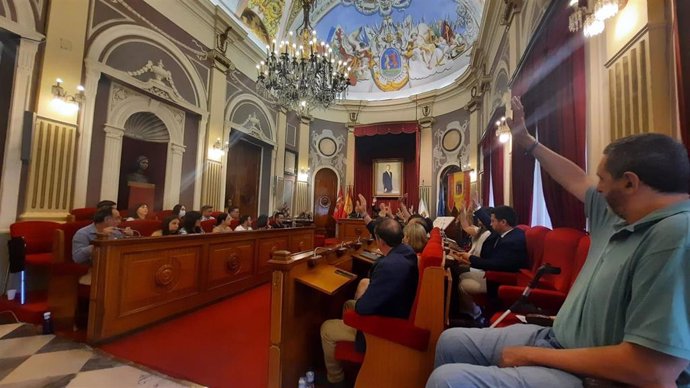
top-left (321, 217), bottom-right (419, 384)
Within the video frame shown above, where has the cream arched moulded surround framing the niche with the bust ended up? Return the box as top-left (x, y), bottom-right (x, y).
top-left (101, 83), bottom-right (185, 209)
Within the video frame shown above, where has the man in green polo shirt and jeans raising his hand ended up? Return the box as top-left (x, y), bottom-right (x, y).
top-left (427, 98), bottom-right (690, 388)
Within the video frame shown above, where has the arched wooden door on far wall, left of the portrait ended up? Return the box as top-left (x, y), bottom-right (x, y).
top-left (314, 168), bottom-right (338, 237)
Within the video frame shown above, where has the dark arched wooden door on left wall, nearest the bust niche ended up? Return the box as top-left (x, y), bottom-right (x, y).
top-left (225, 140), bottom-right (262, 219)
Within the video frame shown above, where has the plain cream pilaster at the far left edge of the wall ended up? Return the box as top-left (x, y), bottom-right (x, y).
top-left (0, 38), bottom-right (38, 230)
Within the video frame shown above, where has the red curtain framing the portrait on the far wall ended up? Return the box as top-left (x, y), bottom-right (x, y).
top-left (354, 122), bottom-right (420, 212)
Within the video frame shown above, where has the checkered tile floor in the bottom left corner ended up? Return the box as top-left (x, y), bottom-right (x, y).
top-left (0, 323), bottom-right (200, 388)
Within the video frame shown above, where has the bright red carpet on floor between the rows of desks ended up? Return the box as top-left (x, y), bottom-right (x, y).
top-left (101, 284), bottom-right (271, 388)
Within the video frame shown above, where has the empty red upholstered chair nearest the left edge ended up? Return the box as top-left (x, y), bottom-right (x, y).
top-left (10, 221), bottom-right (60, 266)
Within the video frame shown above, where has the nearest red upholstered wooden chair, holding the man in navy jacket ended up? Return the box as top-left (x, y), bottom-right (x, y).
top-left (335, 228), bottom-right (445, 388)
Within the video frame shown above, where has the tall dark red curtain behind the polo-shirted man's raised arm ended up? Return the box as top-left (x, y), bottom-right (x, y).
top-left (513, 5), bottom-right (586, 229)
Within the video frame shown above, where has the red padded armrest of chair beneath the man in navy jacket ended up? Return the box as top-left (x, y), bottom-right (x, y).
top-left (343, 310), bottom-right (431, 351)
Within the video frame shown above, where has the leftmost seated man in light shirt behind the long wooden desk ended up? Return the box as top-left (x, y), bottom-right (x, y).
top-left (72, 205), bottom-right (132, 285)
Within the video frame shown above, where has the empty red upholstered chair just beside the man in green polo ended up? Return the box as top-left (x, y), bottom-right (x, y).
top-left (498, 228), bottom-right (590, 313)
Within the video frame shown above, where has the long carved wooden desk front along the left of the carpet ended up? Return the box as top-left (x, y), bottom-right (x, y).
top-left (87, 227), bottom-right (314, 342)
